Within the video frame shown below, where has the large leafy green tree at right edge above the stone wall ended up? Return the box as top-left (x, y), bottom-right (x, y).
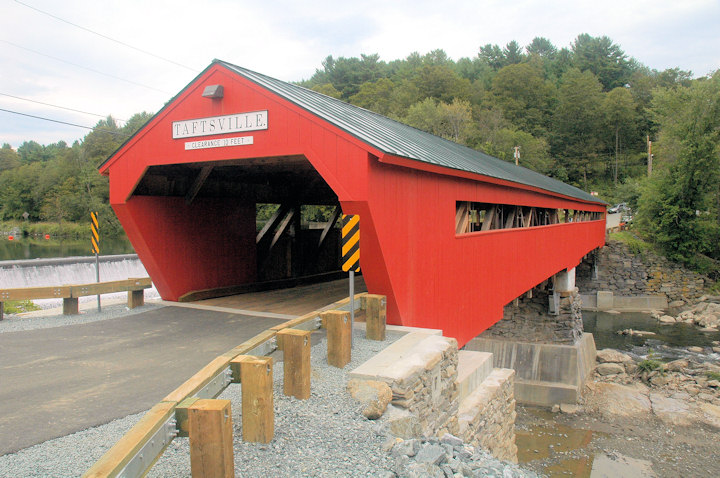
top-left (639, 71), bottom-right (720, 264)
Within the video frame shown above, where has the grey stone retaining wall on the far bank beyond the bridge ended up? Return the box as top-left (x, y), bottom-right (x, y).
top-left (576, 241), bottom-right (706, 301)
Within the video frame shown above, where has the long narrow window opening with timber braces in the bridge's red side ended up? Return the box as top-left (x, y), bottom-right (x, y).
top-left (455, 201), bottom-right (602, 234)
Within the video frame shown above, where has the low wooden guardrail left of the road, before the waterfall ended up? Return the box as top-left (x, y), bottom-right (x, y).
top-left (0, 277), bottom-right (152, 320)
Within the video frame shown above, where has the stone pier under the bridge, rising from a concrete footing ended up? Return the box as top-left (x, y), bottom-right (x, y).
top-left (480, 289), bottom-right (583, 344)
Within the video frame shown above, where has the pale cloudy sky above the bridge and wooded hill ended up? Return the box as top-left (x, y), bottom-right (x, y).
top-left (0, 0), bottom-right (720, 148)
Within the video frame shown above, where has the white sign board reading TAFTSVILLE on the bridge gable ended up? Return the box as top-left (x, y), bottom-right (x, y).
top-left (173, 110), bottom-right (267, 140)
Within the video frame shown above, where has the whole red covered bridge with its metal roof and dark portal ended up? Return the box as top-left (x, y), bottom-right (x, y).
top-left (100, 61), bottom-right (605, 345)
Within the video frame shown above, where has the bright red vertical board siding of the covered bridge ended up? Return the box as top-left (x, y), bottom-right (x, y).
top-left (101, 63), bottom-right (605, 345)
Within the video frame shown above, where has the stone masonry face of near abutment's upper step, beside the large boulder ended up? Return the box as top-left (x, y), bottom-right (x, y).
top-left (389, 337), bottom-right (459, 437)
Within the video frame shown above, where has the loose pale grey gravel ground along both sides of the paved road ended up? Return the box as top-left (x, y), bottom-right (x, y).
top-left (0, 312), bottom-right (534, 478)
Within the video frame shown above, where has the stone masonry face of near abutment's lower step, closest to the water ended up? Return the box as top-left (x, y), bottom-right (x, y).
top-left (458, 368), bottom-right (517, 463)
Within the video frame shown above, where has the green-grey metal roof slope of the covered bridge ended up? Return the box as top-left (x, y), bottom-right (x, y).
top-left (218, 60), bottom-right (603, 203)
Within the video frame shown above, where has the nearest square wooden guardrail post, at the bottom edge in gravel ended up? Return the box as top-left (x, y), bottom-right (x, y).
top-left (188, 399), bottom-right (235, 478)
